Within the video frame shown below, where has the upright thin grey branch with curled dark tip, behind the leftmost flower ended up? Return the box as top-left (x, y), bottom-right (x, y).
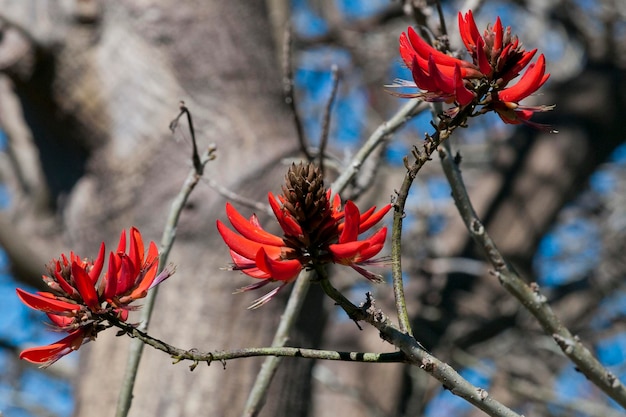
top-left (115, 109), bottom-right (216, 417)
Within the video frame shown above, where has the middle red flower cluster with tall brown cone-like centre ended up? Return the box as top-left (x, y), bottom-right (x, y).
top-left (217, 165), bottom-right (391, 308)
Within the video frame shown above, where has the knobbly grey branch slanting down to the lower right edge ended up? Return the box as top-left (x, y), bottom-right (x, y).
top-left (439, 139), bottom-right (626, 408)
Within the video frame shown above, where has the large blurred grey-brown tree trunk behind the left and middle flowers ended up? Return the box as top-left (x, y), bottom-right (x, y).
top-left (0, 0), bottom-right (322, 417)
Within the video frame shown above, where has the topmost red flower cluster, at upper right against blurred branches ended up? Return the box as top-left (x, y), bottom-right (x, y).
top-left (393, 11), bottom-right (553, 126)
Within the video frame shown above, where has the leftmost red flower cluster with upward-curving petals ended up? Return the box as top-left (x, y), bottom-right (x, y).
top-left (16, 227), bottom-right (172, 367)
